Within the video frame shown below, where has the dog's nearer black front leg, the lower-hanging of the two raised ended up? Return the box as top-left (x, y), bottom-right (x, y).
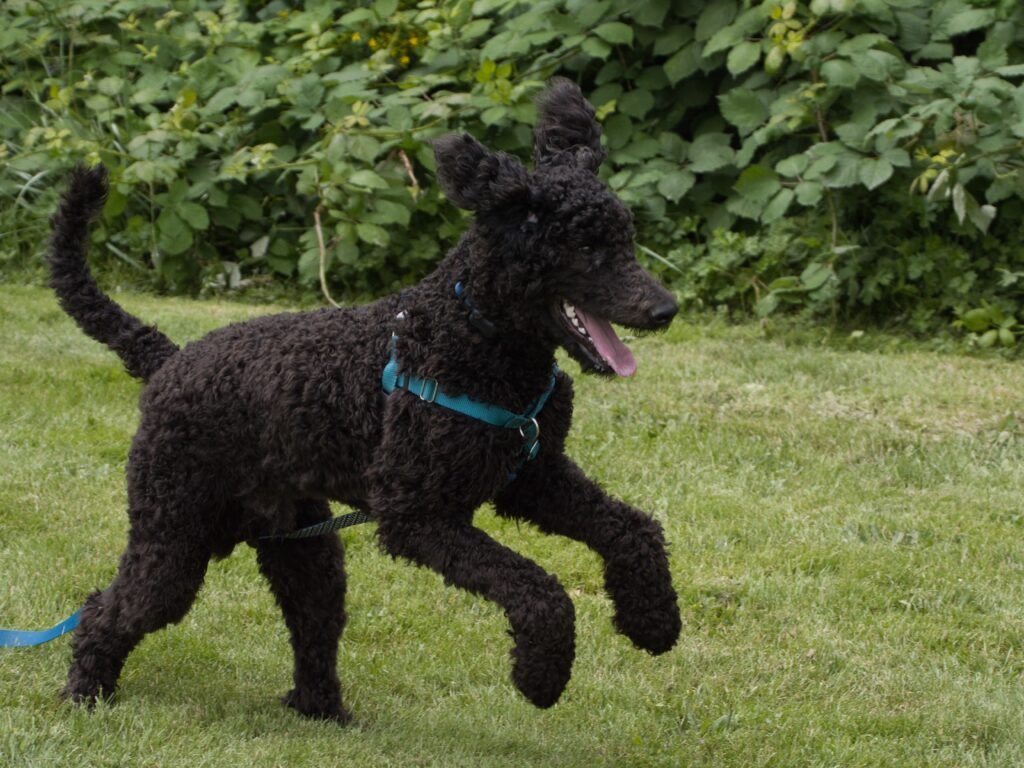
top-left (377, 509), bottom-right (575, 708)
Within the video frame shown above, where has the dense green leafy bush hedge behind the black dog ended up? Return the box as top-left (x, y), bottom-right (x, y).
top-left (0, 0), bottom-right (1024, 343)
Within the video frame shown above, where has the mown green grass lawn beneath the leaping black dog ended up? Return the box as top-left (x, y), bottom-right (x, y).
top-left (0, 287), bottom-right (1024, 768)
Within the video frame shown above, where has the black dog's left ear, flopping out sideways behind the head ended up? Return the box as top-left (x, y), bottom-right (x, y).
top-left (433, 133), bottom-right (529, 213)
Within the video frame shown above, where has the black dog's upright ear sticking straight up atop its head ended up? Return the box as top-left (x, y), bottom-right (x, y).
top-left (534, 78), bottom-right (605, 173)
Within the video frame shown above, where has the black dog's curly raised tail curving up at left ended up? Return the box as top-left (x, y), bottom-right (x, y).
top-left (47, 166), bottom-right (178, 381)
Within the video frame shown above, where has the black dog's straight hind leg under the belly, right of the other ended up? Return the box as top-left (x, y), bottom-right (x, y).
top-left (256, 501), bottom-right (350, 723)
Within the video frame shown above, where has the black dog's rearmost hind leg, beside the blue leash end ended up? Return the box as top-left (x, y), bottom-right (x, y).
top-left (62, 516), bottom-right (210, 705)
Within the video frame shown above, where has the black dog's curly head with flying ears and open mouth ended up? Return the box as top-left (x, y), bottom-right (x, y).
top-left (434, 78), bottom-right (678, 376)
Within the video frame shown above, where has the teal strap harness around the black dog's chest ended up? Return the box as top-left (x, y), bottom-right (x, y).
top-left (381, 333), bottom-right (558, 468)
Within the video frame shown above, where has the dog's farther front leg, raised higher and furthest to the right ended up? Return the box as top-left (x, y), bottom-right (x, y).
top-left (496, 454), bottom-right (681, 654)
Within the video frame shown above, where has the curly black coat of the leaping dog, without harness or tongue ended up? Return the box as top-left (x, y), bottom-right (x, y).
top-left (50, 80), bottom-right (680, 722)
